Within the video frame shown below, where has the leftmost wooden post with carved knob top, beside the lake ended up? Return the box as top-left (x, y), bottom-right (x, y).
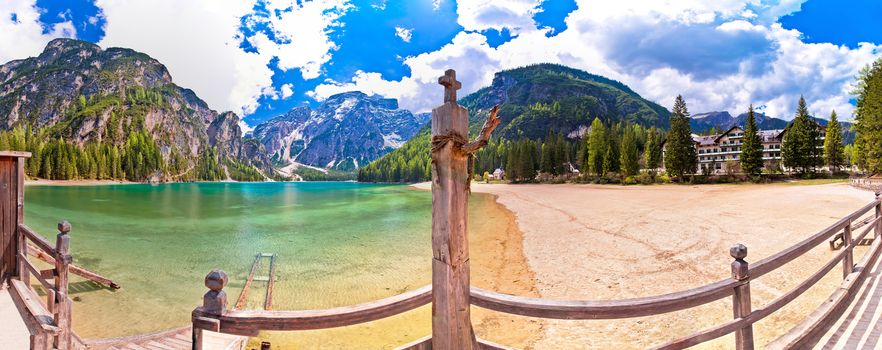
top-left (55, 221), bottom-right (73, 349)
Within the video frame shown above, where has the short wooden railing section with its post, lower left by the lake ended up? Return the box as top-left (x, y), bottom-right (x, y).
top-left (13, 221), bottom-right (74, 349)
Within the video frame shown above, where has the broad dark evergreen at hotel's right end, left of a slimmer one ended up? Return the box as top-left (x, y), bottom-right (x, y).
top-left (781, 96), bottom-right (824, 174)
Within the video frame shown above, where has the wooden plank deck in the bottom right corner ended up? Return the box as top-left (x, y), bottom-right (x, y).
top-left (815, 246), bottom-right (882, 350)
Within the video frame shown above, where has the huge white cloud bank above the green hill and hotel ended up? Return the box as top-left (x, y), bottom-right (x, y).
top-left (310, 0), bottom-right (882, 119)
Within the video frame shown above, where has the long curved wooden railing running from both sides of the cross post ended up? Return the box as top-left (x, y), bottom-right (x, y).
top-left (192, 197), bottom-right (882, 349)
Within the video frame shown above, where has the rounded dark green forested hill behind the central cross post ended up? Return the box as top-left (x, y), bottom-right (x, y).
top-left (358, 64), bottom-right (670, 182)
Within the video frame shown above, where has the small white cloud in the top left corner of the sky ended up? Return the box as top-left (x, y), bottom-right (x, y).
top-left (0, 0), bottom-right (77, 64)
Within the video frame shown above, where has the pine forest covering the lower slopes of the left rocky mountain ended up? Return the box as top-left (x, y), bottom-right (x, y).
top-left (0, 88), bottom-right (264, 181)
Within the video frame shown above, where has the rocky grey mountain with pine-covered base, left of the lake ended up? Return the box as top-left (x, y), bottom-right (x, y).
top-left (0, 39), bottom-right (272, 181)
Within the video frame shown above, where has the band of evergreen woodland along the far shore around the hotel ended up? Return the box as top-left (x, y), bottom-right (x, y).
top-left (358, 60), bottom-right (882, 183)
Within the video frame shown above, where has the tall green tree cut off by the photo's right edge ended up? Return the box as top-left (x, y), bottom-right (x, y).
top-left (852, 58), bottom-right (882, 174)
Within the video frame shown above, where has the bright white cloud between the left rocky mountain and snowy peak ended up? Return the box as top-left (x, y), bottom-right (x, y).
top-left (96, 0), bottom-right (349, 115)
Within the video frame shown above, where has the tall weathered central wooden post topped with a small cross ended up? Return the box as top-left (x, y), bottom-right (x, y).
top-left (432, 69), bottom-right (478, 350)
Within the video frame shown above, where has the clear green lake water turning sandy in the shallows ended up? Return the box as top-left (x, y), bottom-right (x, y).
top-left (18, 183), bottom-right (438, 338)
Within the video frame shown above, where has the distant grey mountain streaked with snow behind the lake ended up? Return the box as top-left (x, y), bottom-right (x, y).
top-left (252, 91), bottom-right (431, 171)
